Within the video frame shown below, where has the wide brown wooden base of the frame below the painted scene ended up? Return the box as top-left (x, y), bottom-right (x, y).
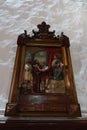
top-left (5, 94), bottom-right (81, 117)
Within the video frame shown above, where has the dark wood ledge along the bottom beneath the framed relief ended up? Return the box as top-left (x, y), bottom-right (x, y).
top-left (0, 117), bottom-right (87, 130)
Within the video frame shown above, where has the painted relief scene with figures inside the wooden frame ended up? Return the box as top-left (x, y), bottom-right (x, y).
top-left (20, 47), bottom-right (65, 94)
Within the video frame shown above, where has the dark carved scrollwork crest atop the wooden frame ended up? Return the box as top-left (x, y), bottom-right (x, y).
top-left (17, 21), bottom-right (70, 47)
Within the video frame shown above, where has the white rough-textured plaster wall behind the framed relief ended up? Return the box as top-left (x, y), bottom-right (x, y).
top-left (0, 0), bottom-right (87, 115)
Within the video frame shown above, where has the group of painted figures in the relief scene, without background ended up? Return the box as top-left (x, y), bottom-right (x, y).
top-left (20, 51), bottom-right (64, 94)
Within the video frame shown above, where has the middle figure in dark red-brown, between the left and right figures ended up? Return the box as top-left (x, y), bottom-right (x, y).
top-left (33, 60), bottom-right (49, 92)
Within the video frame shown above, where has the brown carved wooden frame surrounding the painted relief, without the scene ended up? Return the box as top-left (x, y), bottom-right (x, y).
top-left (5, 22), bottom-right (81, 117)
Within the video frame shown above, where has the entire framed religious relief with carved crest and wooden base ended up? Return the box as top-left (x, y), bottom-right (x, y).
top-left (5, 22), bottom-right (81, 117)
